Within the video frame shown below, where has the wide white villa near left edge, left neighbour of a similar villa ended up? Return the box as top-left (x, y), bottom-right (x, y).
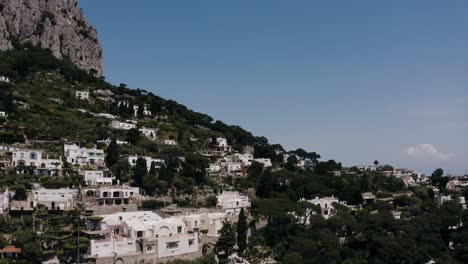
top-left (12, 150), bottom-right (63, 176)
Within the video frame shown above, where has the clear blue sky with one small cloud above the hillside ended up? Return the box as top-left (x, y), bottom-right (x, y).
top-left (79, 0), bottom-right (468, 174)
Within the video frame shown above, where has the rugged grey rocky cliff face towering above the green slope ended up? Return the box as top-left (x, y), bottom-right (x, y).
top-left (0, 0), bottom-right (102, 76)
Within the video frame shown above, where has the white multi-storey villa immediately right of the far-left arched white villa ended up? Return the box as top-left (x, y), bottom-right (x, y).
top-left (63, 143), bottom-right (105, 166)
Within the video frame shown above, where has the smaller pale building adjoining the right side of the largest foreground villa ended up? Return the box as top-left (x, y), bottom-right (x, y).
top-left (174, 213), bottom-right (228, 237)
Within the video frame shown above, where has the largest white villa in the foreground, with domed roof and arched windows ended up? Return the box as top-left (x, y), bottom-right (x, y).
top-left (89, 211), bottom-right (198, 264)
